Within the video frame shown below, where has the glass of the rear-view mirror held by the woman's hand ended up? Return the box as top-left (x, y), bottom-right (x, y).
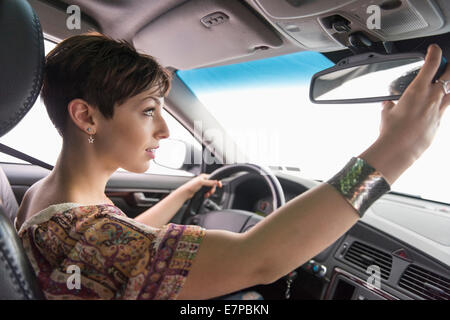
top-left (311, 57), bottom-right (424, 103)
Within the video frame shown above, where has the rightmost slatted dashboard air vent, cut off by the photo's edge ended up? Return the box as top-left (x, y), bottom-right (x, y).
top-left (398, 265), bottom-right (450, 300)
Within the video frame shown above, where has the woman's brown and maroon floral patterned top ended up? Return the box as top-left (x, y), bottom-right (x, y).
top-left (15, 203), bottom-right (205, 299)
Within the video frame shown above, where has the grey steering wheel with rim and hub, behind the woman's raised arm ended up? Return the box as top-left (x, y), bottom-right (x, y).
top-left (184, 163), bottom-right (285, 232)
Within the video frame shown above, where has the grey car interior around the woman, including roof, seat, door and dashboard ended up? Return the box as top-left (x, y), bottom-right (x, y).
top-left (0, 0), bottom-right (450, 300)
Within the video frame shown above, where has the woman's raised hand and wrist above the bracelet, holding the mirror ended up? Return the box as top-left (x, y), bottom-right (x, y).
top-left (360, 45), bottom-right (450, 185)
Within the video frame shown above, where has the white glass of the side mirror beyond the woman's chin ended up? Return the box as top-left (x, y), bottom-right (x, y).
top-left (153, 138), bottom-right (187, 169)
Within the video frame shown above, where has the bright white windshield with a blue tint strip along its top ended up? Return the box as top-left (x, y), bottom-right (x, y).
top-left (177, 52), bottom-right (450, 203)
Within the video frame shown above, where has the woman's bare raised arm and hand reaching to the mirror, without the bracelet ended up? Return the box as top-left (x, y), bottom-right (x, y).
top-left (178, 45), bottom-right (450, 299)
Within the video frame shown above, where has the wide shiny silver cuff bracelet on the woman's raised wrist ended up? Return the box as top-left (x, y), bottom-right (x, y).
top-left (327, 157), bottom-right (391, 217)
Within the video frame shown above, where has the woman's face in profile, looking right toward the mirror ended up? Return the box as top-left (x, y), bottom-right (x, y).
top-left (94, 90), bottom-right (169, 173)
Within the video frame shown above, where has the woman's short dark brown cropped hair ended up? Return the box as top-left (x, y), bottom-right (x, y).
top-left (41, 32), bottom-right (172, 137)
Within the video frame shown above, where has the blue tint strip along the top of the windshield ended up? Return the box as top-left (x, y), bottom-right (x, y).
top-left (177, 51), bottom-right (334, 93)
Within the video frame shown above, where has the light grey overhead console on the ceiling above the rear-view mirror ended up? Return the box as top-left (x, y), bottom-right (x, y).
top-left (254, 0), bottom-right (450, 52)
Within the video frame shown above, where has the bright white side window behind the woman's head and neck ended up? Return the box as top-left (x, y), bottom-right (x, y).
top-left (0, 40), bottom-right (197, 176)
